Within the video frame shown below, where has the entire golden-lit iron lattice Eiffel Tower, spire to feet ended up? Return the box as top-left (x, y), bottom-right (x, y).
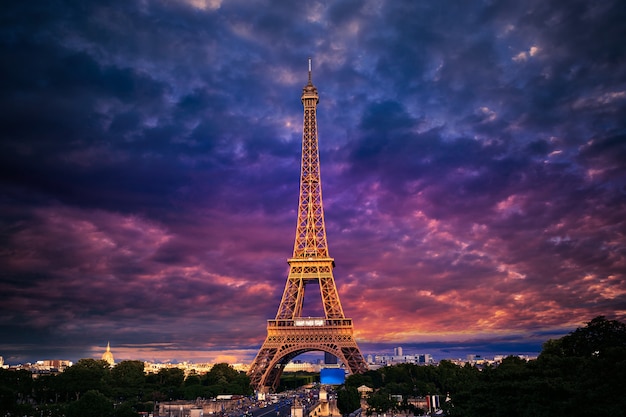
top-left (248, 58), bottom-right (367, 392)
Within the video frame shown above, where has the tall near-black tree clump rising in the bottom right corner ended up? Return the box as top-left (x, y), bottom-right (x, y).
top-left (450, 316), bottom-right (626, 417)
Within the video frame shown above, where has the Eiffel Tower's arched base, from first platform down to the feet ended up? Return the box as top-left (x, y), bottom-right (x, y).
top-left (248, 318), bottom-right (367, 392)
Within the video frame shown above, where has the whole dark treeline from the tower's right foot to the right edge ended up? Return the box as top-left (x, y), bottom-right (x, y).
top-left (339, 316), bottom-right (626, 417)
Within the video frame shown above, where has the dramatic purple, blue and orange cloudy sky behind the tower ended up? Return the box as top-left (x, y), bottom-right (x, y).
top-left (0, 0), bottom-right (626, 363)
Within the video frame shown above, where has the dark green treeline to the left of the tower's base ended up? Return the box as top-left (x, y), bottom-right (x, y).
top-left (0, 359), bottom-right (253, 417)
